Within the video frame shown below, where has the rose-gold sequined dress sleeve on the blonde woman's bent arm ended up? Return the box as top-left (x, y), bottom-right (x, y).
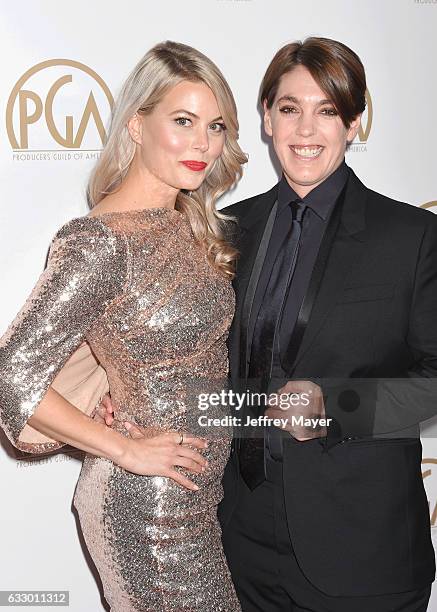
top-left (0, 217), bottom-right (128, 453)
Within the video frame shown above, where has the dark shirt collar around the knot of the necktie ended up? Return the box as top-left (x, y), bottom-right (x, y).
top-left (278, 159), bottom-right (349, 220)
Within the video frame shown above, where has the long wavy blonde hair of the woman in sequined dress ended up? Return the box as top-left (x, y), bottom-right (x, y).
top-left (87, 41), bottom-right (247, 278)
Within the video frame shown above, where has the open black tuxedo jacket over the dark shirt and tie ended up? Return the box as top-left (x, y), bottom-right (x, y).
top-left (219, 171), bottom-right (437, 596)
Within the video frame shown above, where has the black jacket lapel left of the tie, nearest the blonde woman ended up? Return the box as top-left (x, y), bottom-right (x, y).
top-left (228, 185), bottom-right (278, 377)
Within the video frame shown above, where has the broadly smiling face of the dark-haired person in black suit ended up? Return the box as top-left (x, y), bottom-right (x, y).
top-left (264, 66), bottom-right (361, 198)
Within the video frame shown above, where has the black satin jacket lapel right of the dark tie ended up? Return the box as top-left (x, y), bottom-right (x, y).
top-left (286, 170), bottom-right (367, 377)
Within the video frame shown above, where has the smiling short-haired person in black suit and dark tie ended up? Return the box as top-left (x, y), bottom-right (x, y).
top-left (219, 38), bottom-right (437, 612)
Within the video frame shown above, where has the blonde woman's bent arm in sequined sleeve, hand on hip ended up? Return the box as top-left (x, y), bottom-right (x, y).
top-left (0, 218), bottom-right (206, 489)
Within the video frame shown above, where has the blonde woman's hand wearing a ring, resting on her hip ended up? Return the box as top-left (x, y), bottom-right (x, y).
top-left (117, 430), bottom-right (208, 491)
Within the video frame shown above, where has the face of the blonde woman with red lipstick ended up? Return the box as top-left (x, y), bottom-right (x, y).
top-left (128, 81), bottom-right (226, 191)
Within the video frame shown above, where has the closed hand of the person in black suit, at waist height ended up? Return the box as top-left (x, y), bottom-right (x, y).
top-left (265, 380), bottom-right (330, 442)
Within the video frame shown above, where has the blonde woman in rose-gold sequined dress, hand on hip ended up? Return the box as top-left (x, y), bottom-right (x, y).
top-left (0, 42), bottom-right (246, 612)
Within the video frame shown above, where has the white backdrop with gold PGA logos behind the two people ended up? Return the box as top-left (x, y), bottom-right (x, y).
top-left (0, 0), bottom-right (437, 612)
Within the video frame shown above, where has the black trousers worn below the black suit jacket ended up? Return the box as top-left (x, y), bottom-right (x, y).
top-left (223, 455), bottom-right (431, 612)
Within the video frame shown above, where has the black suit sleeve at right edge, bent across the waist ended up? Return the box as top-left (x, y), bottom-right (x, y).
top-left (315, 214), bottom-right (437, 446)
